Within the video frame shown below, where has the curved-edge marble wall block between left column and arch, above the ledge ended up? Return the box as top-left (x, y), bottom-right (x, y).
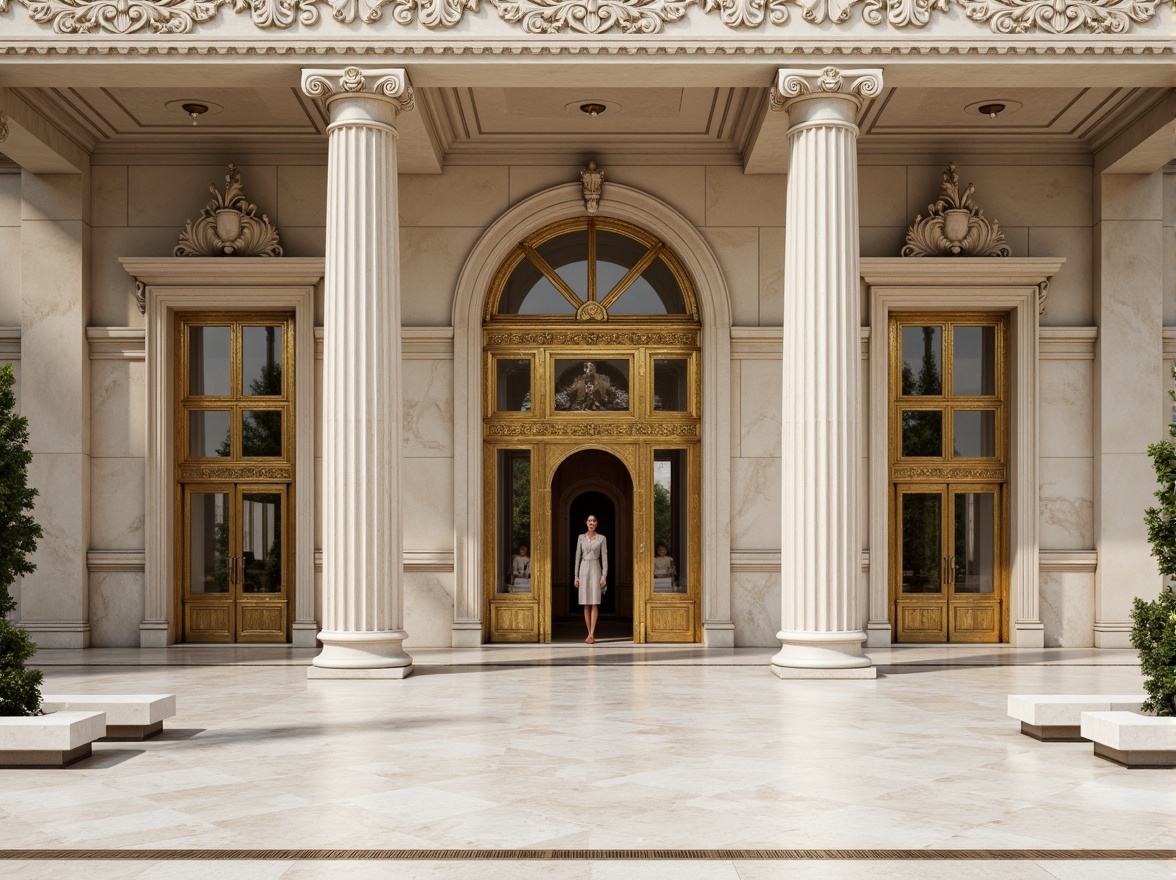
top-left (400, 226), bottom-right (483, 327)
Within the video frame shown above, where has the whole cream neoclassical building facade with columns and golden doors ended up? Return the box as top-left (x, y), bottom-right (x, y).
top-left (0, 6), bottom-right (1176, 678)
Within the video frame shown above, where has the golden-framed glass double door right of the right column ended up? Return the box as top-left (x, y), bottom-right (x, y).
top-left (889, 314), bottom-right (1008, 642)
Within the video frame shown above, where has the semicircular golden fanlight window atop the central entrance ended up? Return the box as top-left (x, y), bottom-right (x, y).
top-left (486, 218), bottom-right (697, 321)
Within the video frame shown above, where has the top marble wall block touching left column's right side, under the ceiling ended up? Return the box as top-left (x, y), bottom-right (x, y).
top-left (400, 165), bottom-right (509, 228)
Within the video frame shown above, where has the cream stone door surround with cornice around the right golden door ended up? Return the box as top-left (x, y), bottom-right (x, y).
top-left (861, 256), bottom-right (1065, 648)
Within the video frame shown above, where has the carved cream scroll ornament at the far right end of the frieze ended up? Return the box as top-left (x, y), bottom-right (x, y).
top-left (956, 0), bottom-right (1157, 34)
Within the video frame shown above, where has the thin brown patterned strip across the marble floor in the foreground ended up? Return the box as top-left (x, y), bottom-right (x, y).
top-left (0, 849), bottom-right (1176, 861)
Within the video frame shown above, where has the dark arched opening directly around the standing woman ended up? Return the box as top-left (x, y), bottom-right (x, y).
top-left (552, 449), bottom-right (634, 641)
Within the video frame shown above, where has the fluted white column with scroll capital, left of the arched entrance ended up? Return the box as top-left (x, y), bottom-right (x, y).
top-left (302, 67), bottom-right (413, 679)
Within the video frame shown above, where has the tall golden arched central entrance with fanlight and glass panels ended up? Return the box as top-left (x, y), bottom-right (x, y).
top-left (482, 215), bottom-right (703, 642)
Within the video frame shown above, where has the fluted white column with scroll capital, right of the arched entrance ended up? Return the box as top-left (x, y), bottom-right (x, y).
top-left (771, 67), bottom-right (882, 678)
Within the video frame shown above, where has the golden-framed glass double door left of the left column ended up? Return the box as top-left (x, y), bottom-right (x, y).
top-left (175, 313), bottom-right (294, 642)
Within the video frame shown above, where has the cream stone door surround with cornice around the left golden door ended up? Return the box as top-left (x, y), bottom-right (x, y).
top-left (119, 256), bottom-right (323, 648)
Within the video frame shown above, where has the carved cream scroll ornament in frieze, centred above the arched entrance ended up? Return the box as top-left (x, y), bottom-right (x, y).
top-left (490, 0), bottom-right (699, 34)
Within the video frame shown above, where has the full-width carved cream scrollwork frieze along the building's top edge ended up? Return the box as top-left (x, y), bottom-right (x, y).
top-left (0, 0), bottom-right (1168, 46)
